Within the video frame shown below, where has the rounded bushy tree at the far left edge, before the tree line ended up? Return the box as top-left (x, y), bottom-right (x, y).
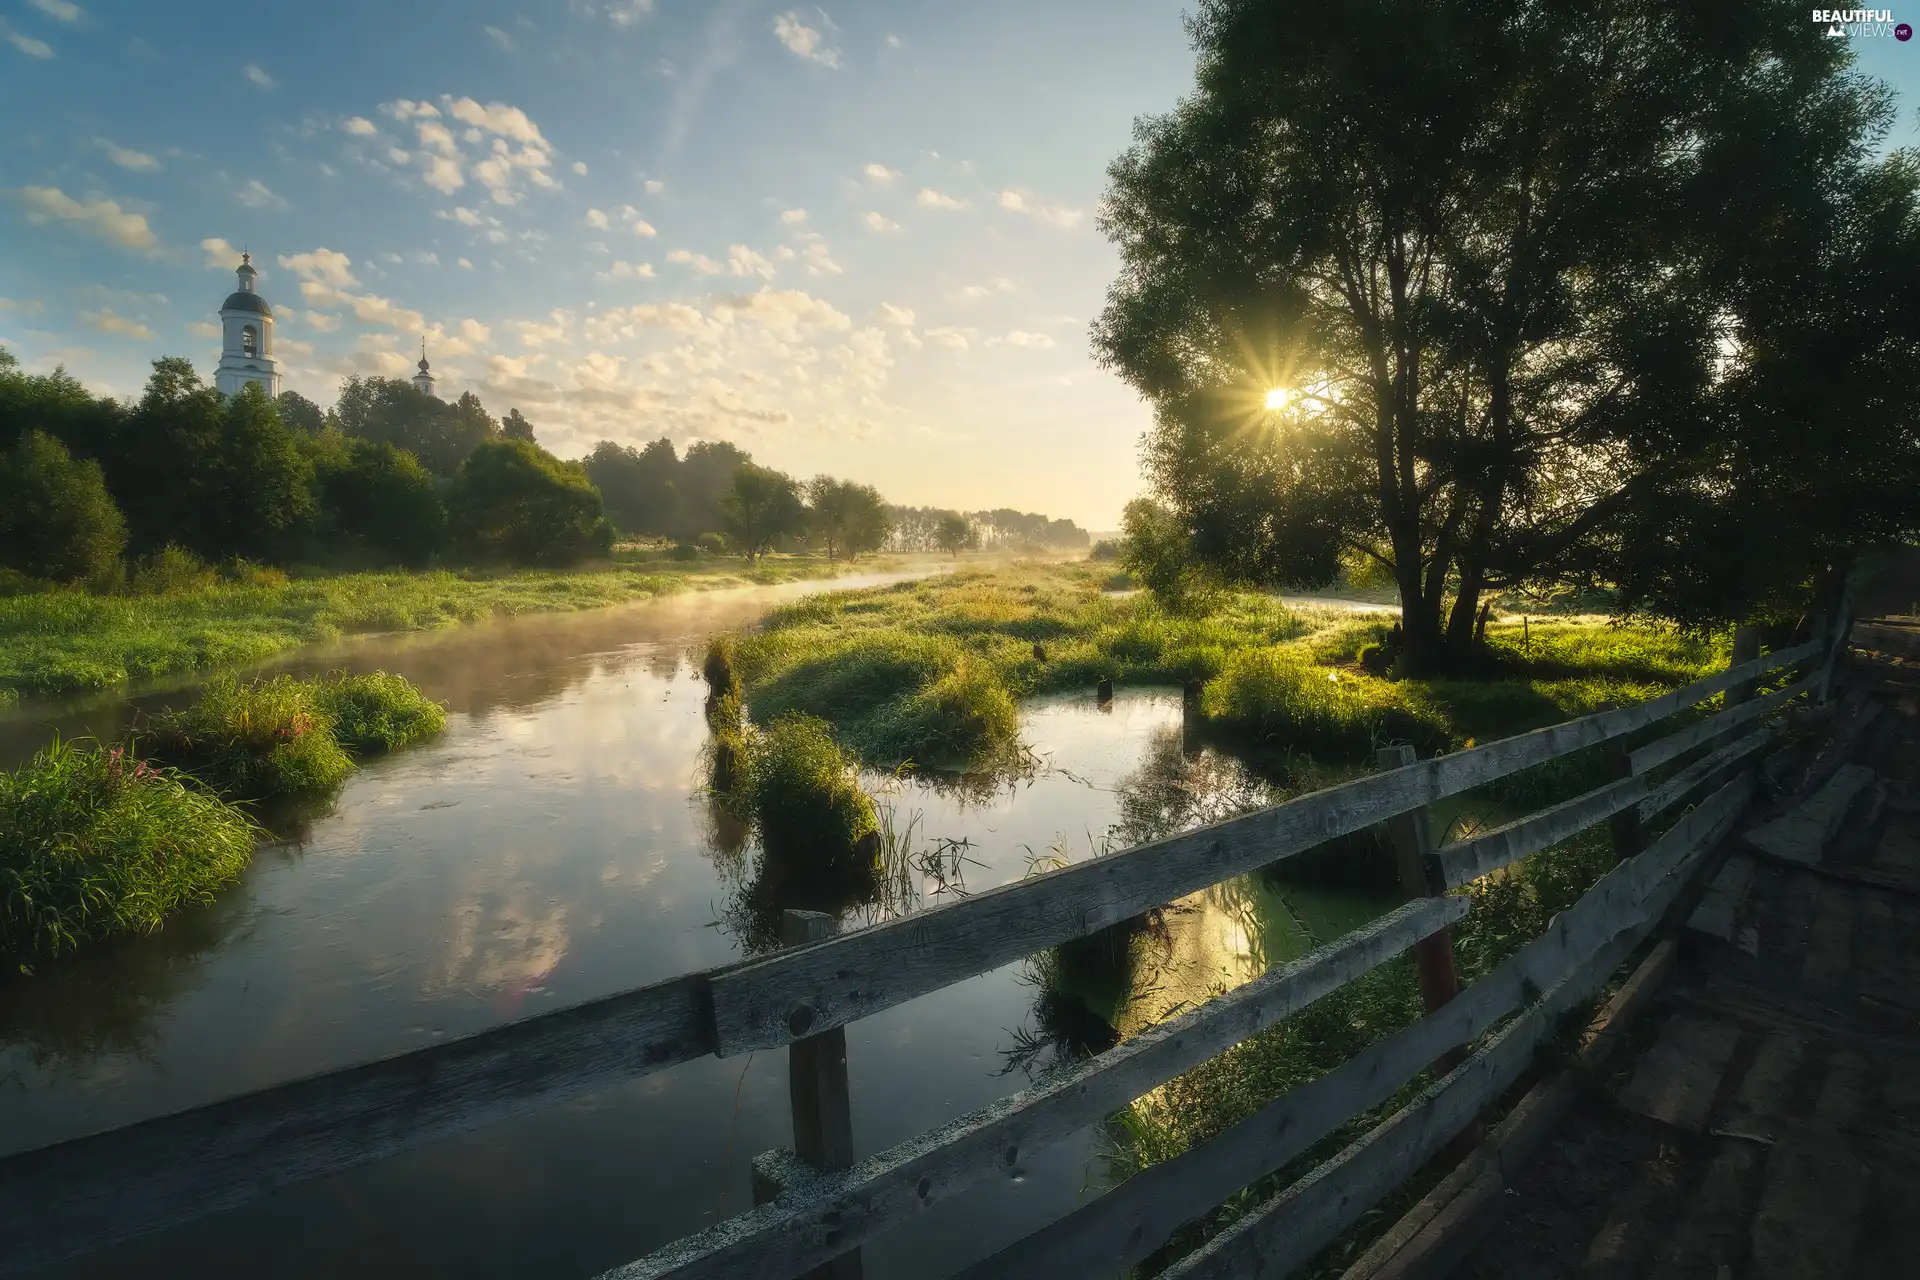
top-left (0, 432), bottom-right (127, 581)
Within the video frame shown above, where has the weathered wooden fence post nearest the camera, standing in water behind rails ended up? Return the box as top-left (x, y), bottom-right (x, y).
top-left (753, 908), bottom-right (862, 1280)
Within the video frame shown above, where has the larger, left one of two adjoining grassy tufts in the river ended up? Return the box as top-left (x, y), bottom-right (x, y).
top-left (138, 676), bottom-right (353, 800)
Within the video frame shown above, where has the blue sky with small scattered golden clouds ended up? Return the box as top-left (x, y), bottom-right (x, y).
top-left (0, 0), bottom-right (1920, 530)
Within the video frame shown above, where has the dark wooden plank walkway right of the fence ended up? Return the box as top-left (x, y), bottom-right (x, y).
top-left (1455, 693), bottom-right (1920, 1280)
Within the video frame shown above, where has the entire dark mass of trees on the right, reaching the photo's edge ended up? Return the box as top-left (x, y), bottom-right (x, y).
top-left (1094, 0), bottom-right (1920, 660)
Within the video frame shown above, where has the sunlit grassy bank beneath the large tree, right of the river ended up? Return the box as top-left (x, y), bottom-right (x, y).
top-left (721, 564), bottom-right (1726, 766)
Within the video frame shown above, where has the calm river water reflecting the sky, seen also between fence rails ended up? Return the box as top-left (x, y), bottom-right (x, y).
top-left (0, 578), bottom-right (1386, 1278)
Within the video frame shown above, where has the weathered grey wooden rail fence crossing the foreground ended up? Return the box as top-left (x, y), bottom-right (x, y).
top-left (0, 624), bottom-right (1832, 1280)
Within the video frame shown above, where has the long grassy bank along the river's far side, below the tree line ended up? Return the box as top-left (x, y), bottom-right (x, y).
top-left (0, 555), bottom-right (910, 706)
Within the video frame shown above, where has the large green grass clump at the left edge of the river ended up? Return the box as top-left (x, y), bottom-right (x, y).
top-left (0, 741), bottom-right (257, 958)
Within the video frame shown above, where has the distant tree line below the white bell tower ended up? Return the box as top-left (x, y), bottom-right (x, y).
top-left (0, 349), bottom-right (1085, 585)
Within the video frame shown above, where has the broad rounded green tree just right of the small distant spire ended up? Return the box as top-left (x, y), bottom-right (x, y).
top-left (447, 439), bottom-right (612, 564)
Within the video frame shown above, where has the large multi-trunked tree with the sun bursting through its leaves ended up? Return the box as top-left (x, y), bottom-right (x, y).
top-left (1094, 0), bottom-right (1912, 670)
